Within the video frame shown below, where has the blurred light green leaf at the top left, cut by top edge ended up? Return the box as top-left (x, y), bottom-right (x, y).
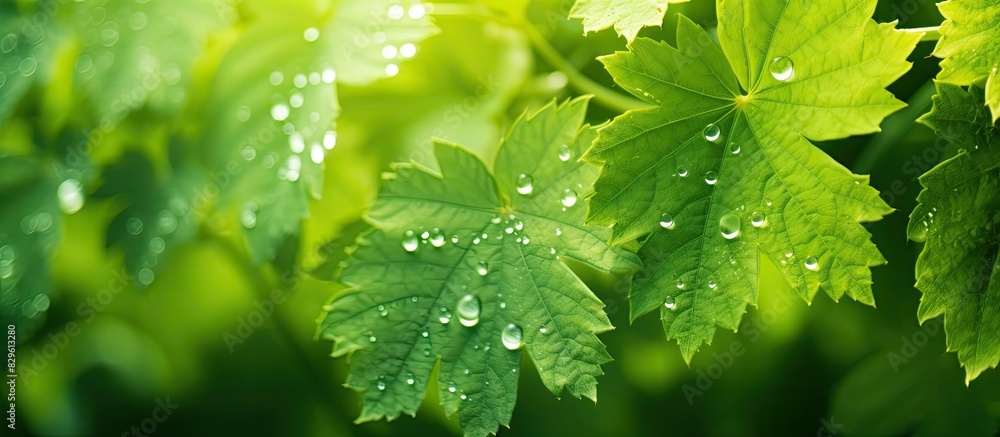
top-left (73, 0), bottom-right (224, 124)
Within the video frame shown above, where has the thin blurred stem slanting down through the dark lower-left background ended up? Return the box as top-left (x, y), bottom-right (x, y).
top-left (200, 227), bottom-right (343, 411)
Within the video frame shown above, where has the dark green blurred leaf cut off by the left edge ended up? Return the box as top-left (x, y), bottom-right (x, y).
top-left (0, 157), bottom-right (62, 339)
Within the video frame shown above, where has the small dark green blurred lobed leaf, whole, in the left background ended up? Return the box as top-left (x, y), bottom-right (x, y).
top-left (94, 152), bottom-right (200, 287)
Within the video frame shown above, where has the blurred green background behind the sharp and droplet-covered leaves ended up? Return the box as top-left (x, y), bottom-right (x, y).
top-left (0, 0), bottom-right (1000, 436)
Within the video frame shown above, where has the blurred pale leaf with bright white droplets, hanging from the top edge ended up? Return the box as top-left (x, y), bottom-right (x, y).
top-left (204, 0), bottom-right (436, 262)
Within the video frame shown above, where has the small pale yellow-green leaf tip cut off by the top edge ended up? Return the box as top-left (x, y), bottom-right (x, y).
top-left (569, 0), bottom-right (688, 42)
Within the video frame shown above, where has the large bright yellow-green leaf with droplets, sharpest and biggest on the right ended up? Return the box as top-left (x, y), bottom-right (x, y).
top-left (584, 0), bottom-right (919, 361)
